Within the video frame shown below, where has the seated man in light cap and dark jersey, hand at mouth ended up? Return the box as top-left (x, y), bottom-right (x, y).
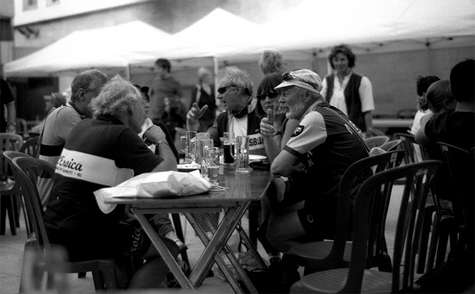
top-left (261, 69), bottom-right (368, 262)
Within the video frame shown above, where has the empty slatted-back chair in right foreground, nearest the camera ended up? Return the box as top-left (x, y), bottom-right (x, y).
top-left (291, 160), bottom-right (441, 293)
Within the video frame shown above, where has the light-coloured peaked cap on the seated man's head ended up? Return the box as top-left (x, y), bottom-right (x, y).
top-left (274, 69), bottom-right (322, 94)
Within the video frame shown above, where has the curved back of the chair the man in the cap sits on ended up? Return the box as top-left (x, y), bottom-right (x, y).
top-left (330, 151), bottom-right (404, 266)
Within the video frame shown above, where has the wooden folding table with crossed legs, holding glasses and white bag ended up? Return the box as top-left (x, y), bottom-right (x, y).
top-left (106, 168), bottom-right (270, 293)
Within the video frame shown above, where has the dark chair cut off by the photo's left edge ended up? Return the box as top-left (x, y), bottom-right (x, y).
top-left (0, 133), bottom-right (23, 235)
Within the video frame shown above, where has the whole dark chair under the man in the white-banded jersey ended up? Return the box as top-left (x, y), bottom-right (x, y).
top-left (13, 157), bottom-right (117, 293)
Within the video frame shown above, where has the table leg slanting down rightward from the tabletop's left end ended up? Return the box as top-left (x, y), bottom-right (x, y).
top-left (132, 209), bottom-right (194, 289)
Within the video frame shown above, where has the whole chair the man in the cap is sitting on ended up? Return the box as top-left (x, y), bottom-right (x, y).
top-left (283, 151), bottom-right (404, 274)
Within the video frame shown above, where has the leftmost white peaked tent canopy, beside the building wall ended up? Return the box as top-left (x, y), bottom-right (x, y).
top-left (4, 21), bottom-right (170, 76)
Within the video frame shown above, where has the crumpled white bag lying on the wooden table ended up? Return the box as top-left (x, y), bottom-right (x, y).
top-left (94, 171), bottom-right (212, 214)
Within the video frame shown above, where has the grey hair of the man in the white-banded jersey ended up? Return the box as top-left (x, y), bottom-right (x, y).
top-left (91, 76), bottom-right (143, 118)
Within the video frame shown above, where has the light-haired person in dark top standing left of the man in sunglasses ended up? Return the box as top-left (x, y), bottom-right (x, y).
top-left (190, 67), bottom-right (216, 132)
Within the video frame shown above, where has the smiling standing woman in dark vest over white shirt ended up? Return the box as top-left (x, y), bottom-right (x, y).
top-left (321, 45), bottom-right (374, 134)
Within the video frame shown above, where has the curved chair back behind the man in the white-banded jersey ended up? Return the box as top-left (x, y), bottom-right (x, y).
top-left (13, 157), bottom-right (54, 248)
